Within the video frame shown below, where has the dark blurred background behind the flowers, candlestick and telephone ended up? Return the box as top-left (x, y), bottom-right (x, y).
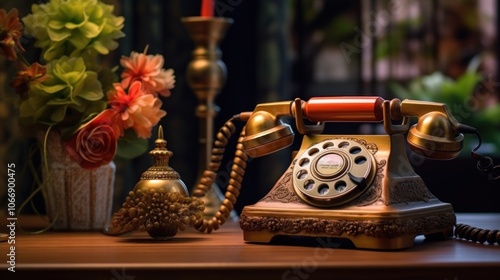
top-left (0, 0), bottom-right (500, 217)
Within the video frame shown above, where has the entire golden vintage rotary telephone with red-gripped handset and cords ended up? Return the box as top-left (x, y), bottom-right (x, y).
top-left (188, 96), bottom-right (500, 250)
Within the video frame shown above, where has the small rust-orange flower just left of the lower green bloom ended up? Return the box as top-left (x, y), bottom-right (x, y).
top-left (10, 62), bottom-right (49, 98)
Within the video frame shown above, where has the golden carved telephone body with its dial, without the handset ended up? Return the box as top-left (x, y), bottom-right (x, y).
top-left (240, 134), bottom-right (456, 250)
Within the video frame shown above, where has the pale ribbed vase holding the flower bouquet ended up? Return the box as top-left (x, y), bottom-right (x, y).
top-left (38, 131), bottom-right (116, 231)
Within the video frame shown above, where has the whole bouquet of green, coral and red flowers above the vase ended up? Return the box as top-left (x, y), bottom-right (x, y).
top-left (0, 0), bottom-right (175, 169)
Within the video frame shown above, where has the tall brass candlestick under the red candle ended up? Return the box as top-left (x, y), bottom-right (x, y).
top-left (182, 17), bottom-right (233, 217)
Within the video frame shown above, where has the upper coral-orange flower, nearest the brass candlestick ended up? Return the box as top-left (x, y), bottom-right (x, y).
top-left (120, 47), bottom-right (175, 97)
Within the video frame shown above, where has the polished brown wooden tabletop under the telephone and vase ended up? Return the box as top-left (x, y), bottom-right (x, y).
top-left (0, 213), bottom-right (500, 280)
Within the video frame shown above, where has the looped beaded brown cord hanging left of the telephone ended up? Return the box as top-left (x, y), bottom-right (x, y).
top-left (193, 115), bottom-right (248, 233)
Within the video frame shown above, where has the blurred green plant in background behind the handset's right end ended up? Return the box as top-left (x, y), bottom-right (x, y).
top-left (389, 58), bottom-right (500, 153)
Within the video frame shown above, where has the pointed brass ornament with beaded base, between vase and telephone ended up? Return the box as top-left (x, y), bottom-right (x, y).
top-left (106, 126), bottom-right (205, 240)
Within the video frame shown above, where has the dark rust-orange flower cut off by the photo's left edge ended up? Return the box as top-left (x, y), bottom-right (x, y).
top-left (0, 8), bottom-right (24, 60)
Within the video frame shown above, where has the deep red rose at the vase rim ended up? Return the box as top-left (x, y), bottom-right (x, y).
top-left (65, 109), bottom-right (117, 169)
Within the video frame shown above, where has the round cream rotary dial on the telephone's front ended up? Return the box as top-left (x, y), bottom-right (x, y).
top-left (293, 139), bottom-right (376, 207)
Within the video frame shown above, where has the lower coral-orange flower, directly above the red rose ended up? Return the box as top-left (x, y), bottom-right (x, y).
top-left (108, 81), bottom-right (167, 138)
